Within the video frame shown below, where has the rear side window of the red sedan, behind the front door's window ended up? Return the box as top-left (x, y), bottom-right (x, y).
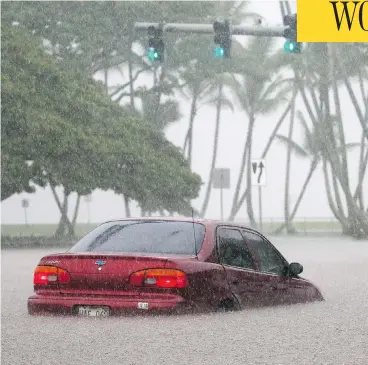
top-left (217, 228), bottom-right (254, 269)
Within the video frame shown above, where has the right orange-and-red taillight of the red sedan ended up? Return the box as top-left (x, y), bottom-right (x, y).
top-left (129, 269), bottom-right (189, 289)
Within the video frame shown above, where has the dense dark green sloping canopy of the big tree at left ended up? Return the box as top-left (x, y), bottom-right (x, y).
top-left (2, 26), bottom-right (201, 211)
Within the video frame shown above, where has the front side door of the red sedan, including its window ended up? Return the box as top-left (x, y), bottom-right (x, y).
top-left (242, 230), bottom-right (293, 305)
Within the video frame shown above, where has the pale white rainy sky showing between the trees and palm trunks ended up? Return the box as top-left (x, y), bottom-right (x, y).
top-left (1, 0), bottom-right (368, 224)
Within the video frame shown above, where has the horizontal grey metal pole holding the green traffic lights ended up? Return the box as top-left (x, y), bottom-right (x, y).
top-left (134, 22), bottom-right (288, 37)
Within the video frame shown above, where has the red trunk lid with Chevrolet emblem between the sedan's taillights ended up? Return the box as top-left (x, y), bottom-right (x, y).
top-left (39, 253), bottom-right (194, 296)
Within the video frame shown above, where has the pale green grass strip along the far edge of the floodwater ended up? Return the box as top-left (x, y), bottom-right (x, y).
top-left (1, 219), bottom-right (341, 237)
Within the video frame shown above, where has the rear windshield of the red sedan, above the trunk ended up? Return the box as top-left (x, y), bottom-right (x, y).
top-left (69, 220), bottom-right (205, 255)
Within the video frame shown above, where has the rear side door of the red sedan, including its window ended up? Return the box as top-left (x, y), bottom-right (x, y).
top-left (216, 226), bottom-right (258, 308)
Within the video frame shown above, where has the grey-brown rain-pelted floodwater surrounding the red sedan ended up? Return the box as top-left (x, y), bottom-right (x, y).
top-left (1, 238), bottom-right (368, 365)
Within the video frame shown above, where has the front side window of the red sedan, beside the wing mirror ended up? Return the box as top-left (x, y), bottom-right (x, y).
top-left (242, 231), bottom-right (287, 275)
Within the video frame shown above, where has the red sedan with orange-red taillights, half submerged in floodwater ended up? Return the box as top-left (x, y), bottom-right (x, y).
top-left (28, 218), bottom-right (323, 316)
